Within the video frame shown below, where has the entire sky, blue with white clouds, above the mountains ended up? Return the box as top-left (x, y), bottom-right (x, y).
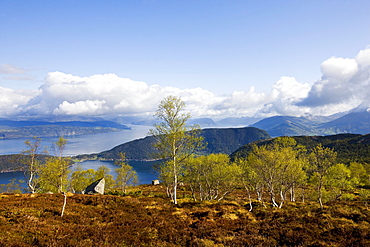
top-left (0, 0), bottom-right (370, 118)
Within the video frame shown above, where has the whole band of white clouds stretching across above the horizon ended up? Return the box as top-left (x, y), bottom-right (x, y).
top-left (0, 48), bottom-right (370, 117)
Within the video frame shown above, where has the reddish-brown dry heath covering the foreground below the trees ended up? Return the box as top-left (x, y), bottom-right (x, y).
top-left (0, 186), bottom-right (370, 247)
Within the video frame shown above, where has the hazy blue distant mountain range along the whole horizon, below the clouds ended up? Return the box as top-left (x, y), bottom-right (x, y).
top-left (0, 104), bottom-right (370, 139)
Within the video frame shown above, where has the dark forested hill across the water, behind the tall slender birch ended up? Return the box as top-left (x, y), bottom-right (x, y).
top-left (76, 127), bottom-right (270, 160)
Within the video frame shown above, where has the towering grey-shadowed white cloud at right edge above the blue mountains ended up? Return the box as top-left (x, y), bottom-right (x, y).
top-left (297, 48), bottom-right (370, 113)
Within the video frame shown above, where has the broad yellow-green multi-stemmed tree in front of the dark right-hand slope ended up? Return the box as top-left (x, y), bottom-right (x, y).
top-left (243, 137), bottom-right (306, 207)
